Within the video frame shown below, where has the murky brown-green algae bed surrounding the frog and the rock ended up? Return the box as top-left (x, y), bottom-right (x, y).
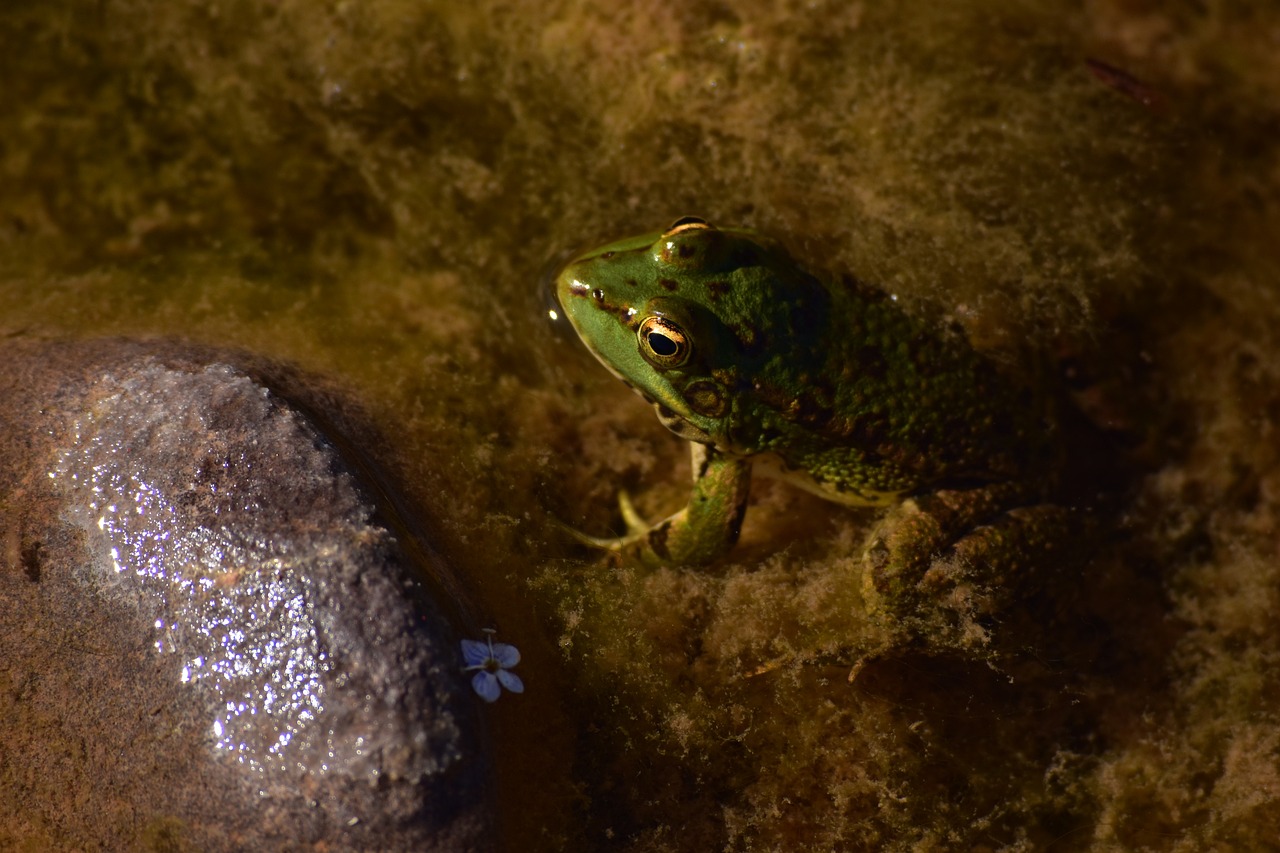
top-left (0, 0), bottom-right (1280, 850)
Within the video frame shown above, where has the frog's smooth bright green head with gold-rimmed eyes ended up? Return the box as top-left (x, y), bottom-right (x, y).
top-left (556, 216), bottom-right (819, 446)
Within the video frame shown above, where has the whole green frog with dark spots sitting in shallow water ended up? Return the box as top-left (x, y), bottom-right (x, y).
top-left (556, 218), bottom-right (1060, 617)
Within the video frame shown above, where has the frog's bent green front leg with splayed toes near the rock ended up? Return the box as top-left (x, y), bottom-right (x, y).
top-left (579, 443), bottom-right (751, 566)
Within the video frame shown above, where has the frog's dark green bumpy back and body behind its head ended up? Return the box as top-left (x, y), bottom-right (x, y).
top-left (739, 266), bottom-right (1056, 503)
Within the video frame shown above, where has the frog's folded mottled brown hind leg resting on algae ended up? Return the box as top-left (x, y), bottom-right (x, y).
top-left (863, 484), bottom-right (1088, 622)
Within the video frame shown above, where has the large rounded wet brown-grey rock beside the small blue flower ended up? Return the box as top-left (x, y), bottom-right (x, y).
top-left (0, 342), bottom-right (493, 850)
